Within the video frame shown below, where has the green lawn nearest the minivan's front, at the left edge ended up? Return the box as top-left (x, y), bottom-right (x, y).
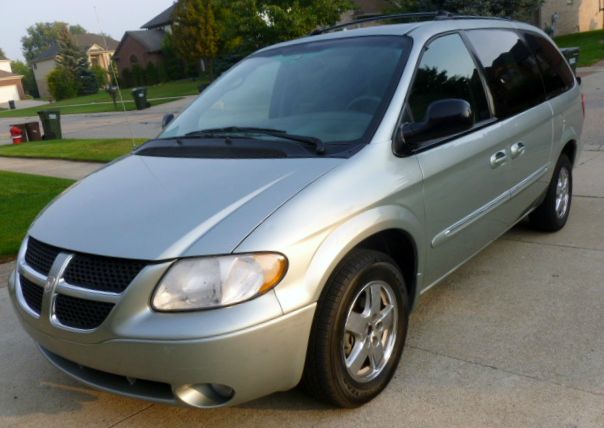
top-left (0, 171), bottom-right (73, 260)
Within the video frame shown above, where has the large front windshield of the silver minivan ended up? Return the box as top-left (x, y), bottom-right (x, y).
top-left (160, 36), bottom-right (410, 151)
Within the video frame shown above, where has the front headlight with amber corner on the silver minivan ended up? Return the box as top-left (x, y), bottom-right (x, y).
top-left (151, 253), bottom-right (287, 311)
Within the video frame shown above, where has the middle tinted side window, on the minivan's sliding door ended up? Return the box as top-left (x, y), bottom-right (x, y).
top-left (467, 30), bottom-right (545, 118)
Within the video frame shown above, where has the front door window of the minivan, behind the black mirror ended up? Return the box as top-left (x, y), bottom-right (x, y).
top-left (404, 34), bottom-right (490, 122)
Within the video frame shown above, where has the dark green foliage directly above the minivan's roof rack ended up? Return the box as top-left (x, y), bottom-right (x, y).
top-left (391, 0), bottom-right (544, 22)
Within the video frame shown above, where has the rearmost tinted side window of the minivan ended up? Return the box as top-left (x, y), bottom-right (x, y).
top-left (524, 33), bottom-right (575, 98)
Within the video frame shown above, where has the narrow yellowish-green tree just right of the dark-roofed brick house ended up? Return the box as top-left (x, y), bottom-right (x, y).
top-left (172, 0), bottom-right (218, 74)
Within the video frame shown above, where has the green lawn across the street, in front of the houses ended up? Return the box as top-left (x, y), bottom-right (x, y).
top-left (0, 79), bottom-right (200, 118)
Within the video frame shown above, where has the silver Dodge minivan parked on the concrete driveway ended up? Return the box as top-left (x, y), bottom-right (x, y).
top-left (9, 14), bottom-right (584, 408)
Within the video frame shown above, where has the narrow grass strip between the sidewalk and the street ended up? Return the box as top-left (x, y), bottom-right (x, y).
top-left (0, 138), bottom-right (146, 162)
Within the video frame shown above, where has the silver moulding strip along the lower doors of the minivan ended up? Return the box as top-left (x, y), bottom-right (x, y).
top-left (431, 163), bottom-right (549, 248)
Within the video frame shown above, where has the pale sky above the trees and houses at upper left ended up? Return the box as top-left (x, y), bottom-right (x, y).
top-left (0, 0), bottom-right (173, 60)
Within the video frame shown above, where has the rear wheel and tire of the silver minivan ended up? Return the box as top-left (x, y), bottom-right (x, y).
top-left (529, 154), bottom-right (573, 232)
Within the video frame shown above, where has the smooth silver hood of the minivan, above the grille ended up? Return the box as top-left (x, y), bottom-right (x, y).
top-left (29, 155), bottom-right (344, 260)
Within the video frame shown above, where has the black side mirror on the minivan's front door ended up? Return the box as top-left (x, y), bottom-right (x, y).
top-left (395, 98), bottom-right (474, 153)
